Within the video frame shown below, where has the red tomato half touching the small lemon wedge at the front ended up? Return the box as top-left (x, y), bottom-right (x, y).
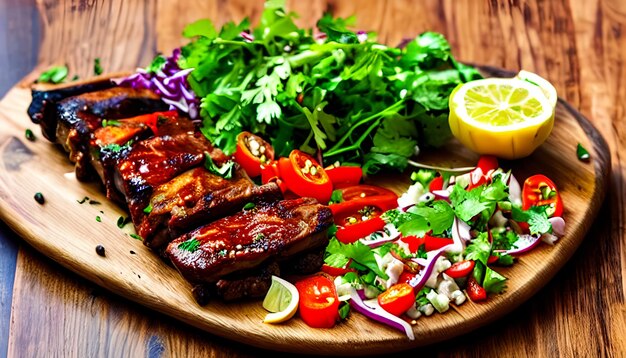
top-left (295, 274), bottom-right (339, 328)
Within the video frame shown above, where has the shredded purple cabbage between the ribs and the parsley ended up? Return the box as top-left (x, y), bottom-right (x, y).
top-left (113, 48), bottom-right (199, 119)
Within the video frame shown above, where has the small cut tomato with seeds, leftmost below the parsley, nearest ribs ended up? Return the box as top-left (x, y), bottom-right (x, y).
top-left (234, 131), bottom-right (274, 177)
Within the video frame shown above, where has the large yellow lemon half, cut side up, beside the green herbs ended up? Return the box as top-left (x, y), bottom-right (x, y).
top-left (448, 72), bottom-right (556, 159)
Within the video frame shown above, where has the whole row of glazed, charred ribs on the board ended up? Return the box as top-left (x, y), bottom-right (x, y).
top-left (29, 80), bottom-right (333, 304)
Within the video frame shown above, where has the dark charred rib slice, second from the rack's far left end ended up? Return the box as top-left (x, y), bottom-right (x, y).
top-left (56, 87), bottom-right (169, 180)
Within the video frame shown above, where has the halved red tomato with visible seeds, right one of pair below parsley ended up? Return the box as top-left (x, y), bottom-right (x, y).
top-left (278, 149), bottom-right (333, 204)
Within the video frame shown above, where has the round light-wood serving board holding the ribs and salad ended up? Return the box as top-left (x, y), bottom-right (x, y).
top-left (0, 68), bottom-right (610, 355)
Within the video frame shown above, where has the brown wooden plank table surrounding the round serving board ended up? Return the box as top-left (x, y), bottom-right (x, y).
top-left (0, 0), bottom-right (626, 357)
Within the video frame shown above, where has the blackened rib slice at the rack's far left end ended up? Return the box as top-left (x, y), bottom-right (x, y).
top-left (27, 73), bottom-right (128, 142)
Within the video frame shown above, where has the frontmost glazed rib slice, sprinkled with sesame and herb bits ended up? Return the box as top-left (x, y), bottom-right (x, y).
top-left (165, 198), bottom-right (333, 284)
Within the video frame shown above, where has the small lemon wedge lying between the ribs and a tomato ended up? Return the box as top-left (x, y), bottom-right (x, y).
top-left (263, 275), bottom-right (300, 323)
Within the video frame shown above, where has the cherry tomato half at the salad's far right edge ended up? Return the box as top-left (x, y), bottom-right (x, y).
top-left (522, 174), bottom-right (563, 217)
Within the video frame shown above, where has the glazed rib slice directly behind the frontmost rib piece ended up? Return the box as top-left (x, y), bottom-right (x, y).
top-left (137, 167), bottom-right (282, 251)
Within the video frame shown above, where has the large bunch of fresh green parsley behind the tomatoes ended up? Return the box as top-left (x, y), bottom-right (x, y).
top-left (179, 0), bottom-right (480, 174)
